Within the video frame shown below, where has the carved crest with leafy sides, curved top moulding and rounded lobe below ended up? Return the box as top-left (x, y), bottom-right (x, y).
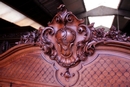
top-left (0, 5), bottom-right (130, 87)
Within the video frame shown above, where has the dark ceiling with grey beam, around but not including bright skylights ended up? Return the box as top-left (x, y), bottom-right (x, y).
top-left (0, 0), bottom-right (130, 35)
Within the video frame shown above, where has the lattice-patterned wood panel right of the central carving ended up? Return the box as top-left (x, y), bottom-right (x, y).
top-left (78, 54), bottom-right (130, 87)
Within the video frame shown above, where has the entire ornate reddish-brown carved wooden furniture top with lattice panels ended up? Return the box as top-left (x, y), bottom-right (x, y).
top-left (0, 5), bottom-right (130, 87)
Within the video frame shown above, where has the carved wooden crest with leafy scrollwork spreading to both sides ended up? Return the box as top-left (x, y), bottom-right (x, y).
top-left (19, 5), bottom-right (130, 68)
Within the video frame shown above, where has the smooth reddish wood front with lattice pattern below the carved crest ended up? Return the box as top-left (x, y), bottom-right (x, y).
top-left (0, 44), bottom-right (130, 87)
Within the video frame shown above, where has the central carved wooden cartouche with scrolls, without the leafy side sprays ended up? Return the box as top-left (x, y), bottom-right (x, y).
top-left (41, 5), bottom-right (91, 68)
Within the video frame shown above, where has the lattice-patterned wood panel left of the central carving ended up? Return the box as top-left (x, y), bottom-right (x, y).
top-left (0, 48), bottom-right (59, 87)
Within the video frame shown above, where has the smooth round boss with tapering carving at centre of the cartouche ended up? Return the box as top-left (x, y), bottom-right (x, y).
top-left (56, 28), bottom-right (76, 57)
